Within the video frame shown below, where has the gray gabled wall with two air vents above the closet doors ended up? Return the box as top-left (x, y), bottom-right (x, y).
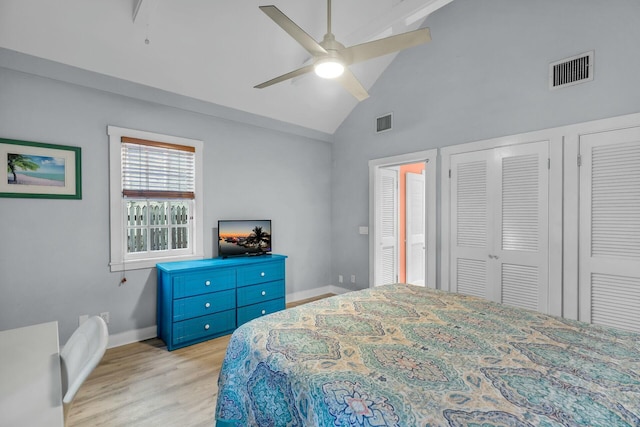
top-left (332, 0), bottom-right (640, 289)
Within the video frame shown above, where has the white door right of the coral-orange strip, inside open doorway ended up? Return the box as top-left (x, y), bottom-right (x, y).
top-left (406, 173), bottom-right (426, 286)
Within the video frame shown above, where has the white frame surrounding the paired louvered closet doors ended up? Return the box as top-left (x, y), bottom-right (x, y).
top-left (440, 132), bottom-right (563, 316)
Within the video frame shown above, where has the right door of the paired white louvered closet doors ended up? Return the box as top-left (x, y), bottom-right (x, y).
top-left (492, 141), bottom-right (549, 313)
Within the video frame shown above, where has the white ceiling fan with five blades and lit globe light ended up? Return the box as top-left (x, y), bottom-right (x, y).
top-left (254, 0), bottom-right (431, 101)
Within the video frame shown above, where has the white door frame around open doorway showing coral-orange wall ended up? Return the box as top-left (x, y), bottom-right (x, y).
top-left (369, 149), bottom-right (440, 289)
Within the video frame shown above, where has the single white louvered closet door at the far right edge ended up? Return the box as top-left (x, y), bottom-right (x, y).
top-left (579, 128), bottom-right (640, 332)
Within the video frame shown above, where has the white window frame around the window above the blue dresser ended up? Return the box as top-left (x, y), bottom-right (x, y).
top-left (107, 126), bottom-right (204, 272)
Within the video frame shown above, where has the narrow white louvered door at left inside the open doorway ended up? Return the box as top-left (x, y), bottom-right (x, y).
top-left (374, 169), bottom-right (398, 286)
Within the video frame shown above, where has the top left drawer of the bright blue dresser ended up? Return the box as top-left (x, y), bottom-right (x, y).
top-left (173, 268), bottom-right (236, 298)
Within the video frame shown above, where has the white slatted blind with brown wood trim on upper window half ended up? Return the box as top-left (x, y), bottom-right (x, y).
top-left (122, 137), bottom-right (195, 199)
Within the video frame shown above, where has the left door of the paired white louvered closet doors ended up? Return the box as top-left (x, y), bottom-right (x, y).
top-left (451, 150), bottom-right (495, 299)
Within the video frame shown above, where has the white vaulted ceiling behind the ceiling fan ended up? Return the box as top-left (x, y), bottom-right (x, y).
top-left (0, 0), bottom-right (452, 134)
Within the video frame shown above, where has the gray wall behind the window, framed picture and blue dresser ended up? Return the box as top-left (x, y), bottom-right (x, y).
top-left (0, 68), bottom-right (331, 343)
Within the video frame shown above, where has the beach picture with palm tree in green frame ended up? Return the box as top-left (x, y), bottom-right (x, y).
top-left (0, 138), bottom-right (82, 199)
